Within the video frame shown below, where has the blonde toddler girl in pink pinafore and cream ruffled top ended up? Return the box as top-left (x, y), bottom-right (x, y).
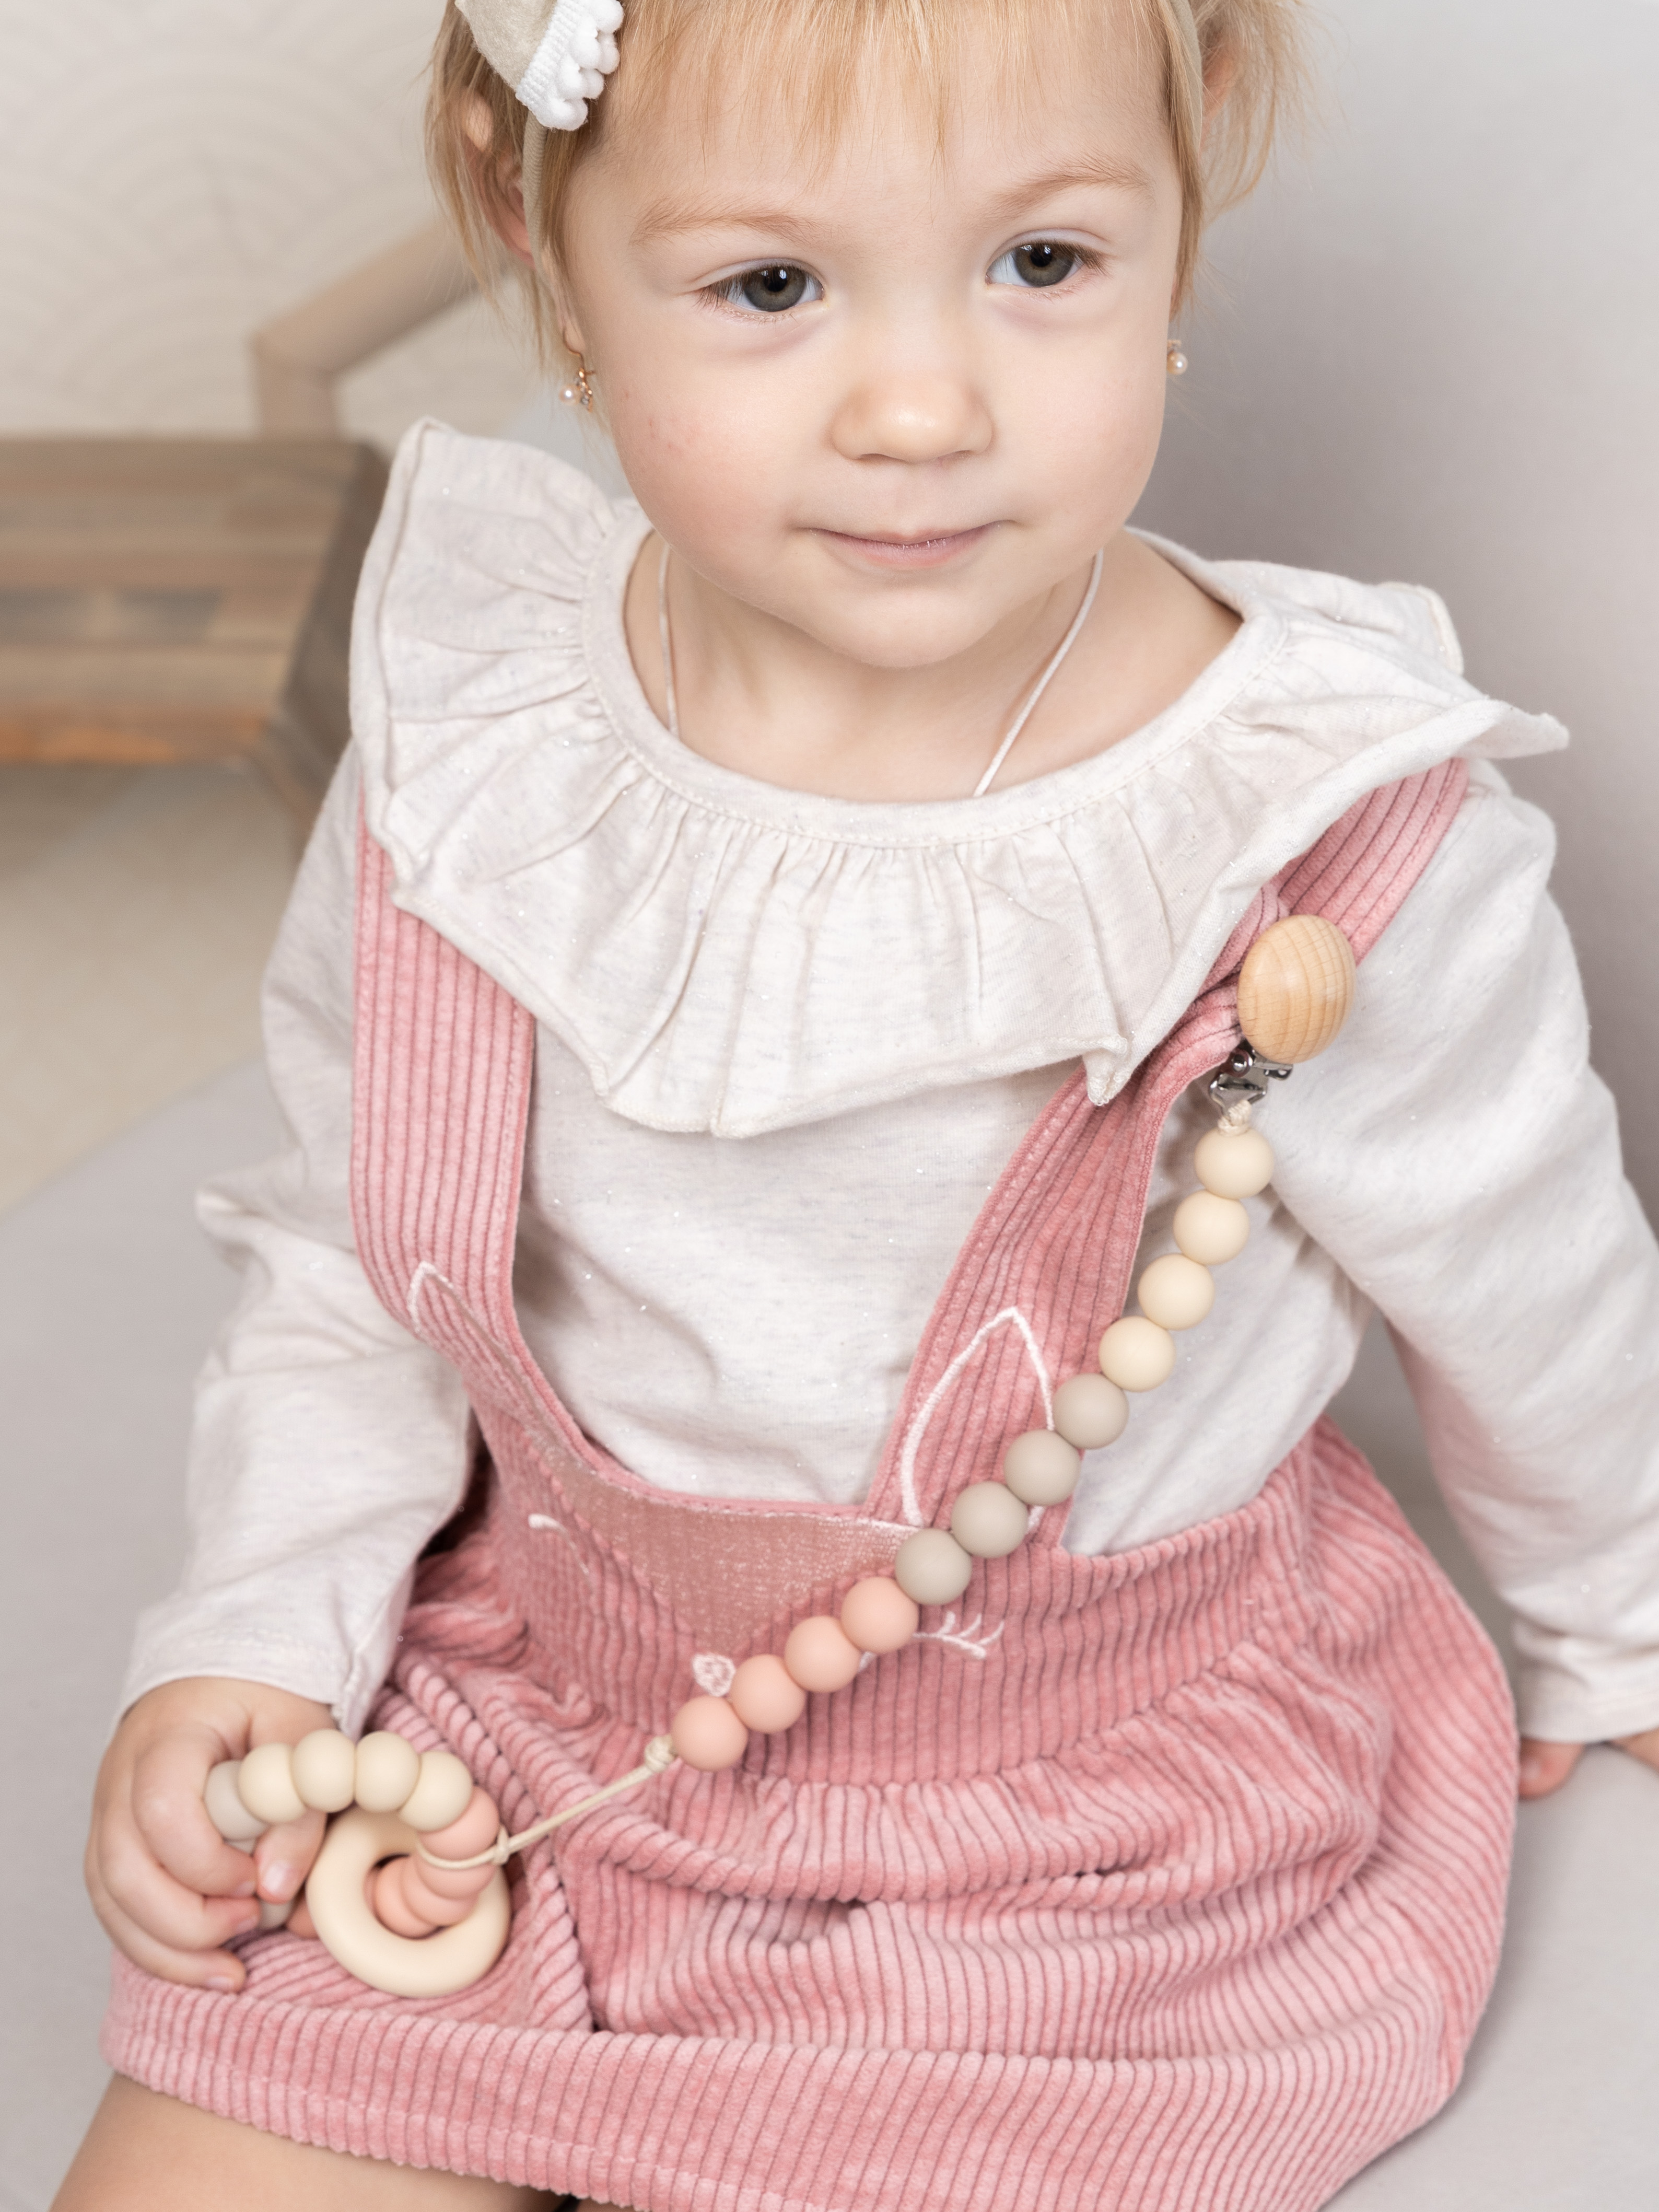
top-left (60, 0), bottom-right (1659, 2212)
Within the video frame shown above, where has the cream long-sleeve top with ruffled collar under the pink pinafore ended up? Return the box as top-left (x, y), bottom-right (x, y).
top-left (126, 427), bottom-right (1659, 1741)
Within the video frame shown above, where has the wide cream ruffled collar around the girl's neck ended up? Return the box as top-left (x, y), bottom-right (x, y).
top-left (352, 423), bottom-right (1566, 1137)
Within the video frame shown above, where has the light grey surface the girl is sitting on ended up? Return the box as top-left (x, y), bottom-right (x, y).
top-left (0, 1068), bottom-right (1659, 2212)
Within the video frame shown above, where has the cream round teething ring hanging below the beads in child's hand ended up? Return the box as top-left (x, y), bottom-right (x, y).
top-left (305, 1805), bottom-right (511, 1997)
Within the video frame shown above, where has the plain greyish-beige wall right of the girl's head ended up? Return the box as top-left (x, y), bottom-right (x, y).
top-left (1141, 0), bottom-right (1659, 1219)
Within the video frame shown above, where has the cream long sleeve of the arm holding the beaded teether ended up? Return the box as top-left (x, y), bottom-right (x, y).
top-left (124, 754), bottom-right (469, 1730)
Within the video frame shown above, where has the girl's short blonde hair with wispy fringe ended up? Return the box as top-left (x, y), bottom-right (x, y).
top-left (427, 0), bottom-right (1307, 354)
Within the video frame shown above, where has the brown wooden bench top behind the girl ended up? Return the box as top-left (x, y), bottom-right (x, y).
top-left (0, 438), bottom-right (387, 823)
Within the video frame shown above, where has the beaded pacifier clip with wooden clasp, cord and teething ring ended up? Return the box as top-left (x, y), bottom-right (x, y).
top-left (206, 914), bottom-right (1354, 1997)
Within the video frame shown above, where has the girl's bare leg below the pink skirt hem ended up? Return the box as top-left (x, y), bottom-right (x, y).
top-left (53, 2075), bottom-right (557, 2212)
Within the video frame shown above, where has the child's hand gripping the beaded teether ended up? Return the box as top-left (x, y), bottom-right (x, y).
top-left (86, 1677), bottom-right (334, 1988)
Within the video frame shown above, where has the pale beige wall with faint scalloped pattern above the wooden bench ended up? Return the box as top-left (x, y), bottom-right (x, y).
top-left (0, 0), bottom-right (531, 443)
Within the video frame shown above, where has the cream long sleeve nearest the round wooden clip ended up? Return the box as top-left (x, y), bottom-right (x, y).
top-left (1272, 772), bottom-right (1659, 1741)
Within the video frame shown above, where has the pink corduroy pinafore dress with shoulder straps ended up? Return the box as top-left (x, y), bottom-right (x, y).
top-left (106, 765), bottom-right (1515, 2212)
